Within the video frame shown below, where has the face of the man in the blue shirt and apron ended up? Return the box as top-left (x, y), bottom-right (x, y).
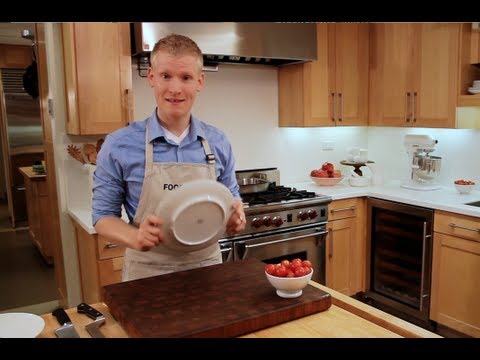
top-left (148, 51), bottom-right (205, 122)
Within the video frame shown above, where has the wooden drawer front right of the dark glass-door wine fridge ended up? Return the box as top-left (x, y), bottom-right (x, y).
top-left (433, 210), bottom-right (480, 242)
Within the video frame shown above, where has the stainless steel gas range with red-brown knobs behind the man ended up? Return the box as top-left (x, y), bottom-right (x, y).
top-left (220, 168), bottom-right (332, 284)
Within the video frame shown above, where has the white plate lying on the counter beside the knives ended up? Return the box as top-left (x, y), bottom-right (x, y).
top-left (0, 313), bottom-right (45, 338)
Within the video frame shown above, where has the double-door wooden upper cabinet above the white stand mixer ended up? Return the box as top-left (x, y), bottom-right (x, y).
top-left (369, 23), bottom-right (461, 128)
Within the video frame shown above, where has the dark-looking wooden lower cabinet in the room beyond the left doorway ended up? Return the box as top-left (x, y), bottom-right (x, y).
top-left (19, 166), bottom-right (54, 265)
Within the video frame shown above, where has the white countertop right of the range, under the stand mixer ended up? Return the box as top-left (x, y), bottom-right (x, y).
top-left (285, 179), bottom-right (480, 220)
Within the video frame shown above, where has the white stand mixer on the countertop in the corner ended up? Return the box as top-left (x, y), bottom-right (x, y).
top-left (401, 134), bottom-right (442, 190)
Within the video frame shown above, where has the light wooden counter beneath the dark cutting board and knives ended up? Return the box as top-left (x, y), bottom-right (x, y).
top-left (38, 281), bottom-right (440, 338)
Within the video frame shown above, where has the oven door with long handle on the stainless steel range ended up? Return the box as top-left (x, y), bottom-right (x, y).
top-left (234, 224), bottom-right (327, 285)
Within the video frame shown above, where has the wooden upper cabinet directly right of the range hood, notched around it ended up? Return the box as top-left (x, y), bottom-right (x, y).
top-left (278, 23), bottom-right (370, 127)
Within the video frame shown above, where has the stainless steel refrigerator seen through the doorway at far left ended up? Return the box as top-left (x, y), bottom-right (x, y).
top-left (0, 69), bottom-right (44, 227)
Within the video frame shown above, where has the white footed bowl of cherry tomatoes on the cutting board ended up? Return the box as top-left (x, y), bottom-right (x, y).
top-left (265, 258), bottom-right (313, 298)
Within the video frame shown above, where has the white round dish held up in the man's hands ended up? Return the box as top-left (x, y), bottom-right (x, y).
top-left (156, 180), bottom-right (235, 252)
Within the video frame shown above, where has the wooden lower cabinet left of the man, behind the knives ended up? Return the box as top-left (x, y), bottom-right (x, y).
top-left (73, 221), bottom-right (125, 303)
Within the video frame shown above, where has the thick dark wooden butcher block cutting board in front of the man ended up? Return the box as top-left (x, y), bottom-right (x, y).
top-left (103, 259), bottom-right (331, 338)
